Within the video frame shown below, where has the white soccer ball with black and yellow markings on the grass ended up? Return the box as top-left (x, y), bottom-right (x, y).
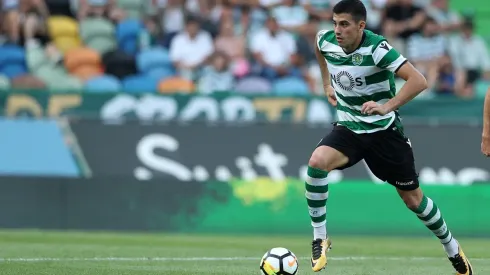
top-left (260, 247), bottom-right (299, 275)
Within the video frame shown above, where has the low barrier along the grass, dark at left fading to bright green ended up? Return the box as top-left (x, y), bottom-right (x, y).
top-left (0, 177), bottom-right (490, 237)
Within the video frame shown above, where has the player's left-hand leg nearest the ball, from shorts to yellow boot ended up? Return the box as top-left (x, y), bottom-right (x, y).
top-left (305, 126), bottom-right (362, 271)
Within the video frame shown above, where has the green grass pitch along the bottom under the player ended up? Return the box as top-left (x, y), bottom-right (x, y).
top-left (0, 231), bottom-right (490, 275)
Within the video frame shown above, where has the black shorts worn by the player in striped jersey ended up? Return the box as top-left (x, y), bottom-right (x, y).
top-left (317, 125), bottom-right (419, 190)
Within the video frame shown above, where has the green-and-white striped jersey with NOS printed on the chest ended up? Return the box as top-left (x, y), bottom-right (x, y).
top-left (317, 30), bottom-right (406, 134)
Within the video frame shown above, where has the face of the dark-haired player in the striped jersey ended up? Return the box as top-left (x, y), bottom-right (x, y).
top-left (333, 13), bottom-right (365, 49)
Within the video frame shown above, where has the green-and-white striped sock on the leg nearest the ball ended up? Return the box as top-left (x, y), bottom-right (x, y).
top-left (305, 166), bottom-right (328, 239)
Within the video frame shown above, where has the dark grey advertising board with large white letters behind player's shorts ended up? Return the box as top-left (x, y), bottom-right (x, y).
top-left (70, 120), bottom-right (490, 185)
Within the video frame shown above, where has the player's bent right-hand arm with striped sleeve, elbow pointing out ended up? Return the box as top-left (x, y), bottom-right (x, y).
top-left (362, 41), bottom-right (427, 115)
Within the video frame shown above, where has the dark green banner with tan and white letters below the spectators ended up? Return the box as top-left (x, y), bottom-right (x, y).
top-left (0, 91), bottom-right (482, 123)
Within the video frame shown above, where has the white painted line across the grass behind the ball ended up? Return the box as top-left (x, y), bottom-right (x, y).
top-left (0, 256), bottom-right (490, 262)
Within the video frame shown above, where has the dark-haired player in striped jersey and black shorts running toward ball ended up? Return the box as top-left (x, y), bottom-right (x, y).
top-left (305, 0), bottom-right (473, 275)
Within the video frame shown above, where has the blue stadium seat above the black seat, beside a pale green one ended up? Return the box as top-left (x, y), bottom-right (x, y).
top-left (116, 19), bottom-right (144, 55)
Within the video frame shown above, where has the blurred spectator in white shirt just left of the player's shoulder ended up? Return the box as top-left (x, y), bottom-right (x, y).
top-left (250, 16), bottom-right (301, 80)
